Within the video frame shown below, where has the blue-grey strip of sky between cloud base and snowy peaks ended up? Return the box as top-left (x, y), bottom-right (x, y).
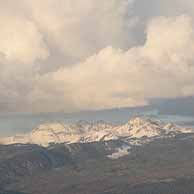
top-left (0, 97), bottom-right (194, 136)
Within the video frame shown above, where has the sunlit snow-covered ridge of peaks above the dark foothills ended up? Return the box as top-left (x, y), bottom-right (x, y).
top-left (0, 118), bottom-right (193, 146)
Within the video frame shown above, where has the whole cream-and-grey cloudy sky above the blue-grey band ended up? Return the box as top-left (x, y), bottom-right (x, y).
top-left (0, 0), bottom-right (194, 113)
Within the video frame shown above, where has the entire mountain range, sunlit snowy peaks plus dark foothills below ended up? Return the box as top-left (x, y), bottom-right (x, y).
top-left (0, 118), bottom-right (194, 194)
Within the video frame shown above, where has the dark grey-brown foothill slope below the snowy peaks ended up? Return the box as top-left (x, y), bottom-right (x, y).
top-left (0, 134), bottom-right (194, 194)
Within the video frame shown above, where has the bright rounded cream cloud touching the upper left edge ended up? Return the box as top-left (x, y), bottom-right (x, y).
top-left (0, 3), bottom-right (49, 64)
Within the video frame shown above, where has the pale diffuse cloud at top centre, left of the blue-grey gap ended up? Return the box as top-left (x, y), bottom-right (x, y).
top-left (23, 0), bottom-right (137, 59)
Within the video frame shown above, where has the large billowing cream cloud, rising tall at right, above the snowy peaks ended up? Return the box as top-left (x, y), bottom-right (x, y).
top-left (26, 15), bottom-right (194, 110)
